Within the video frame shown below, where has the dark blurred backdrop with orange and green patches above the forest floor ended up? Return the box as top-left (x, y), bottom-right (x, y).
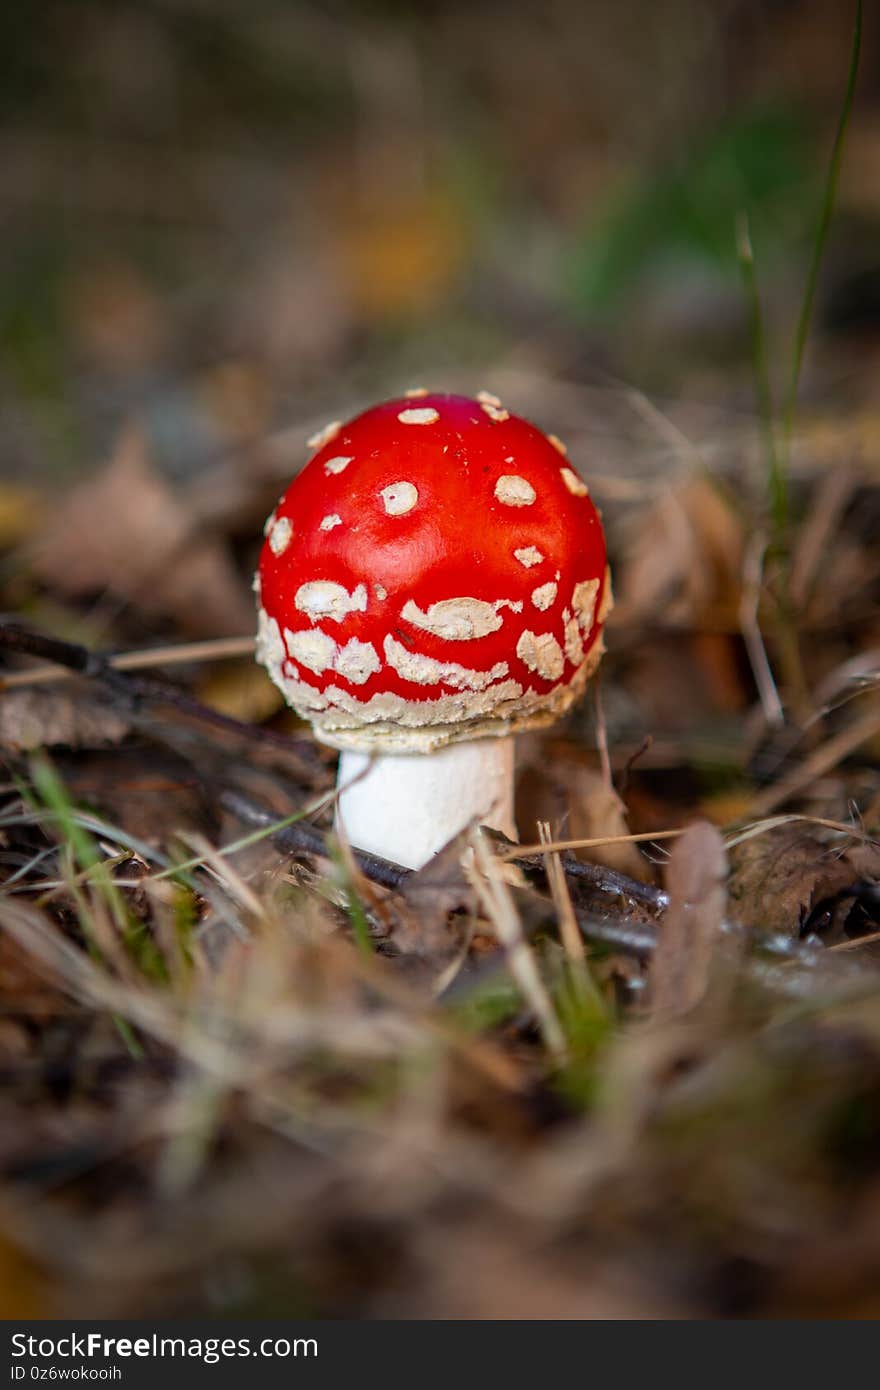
top-left (0, 0), bottom-right (880, 494)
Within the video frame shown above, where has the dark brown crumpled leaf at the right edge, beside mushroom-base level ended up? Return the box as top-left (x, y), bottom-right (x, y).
top-left (728, 824), bottom-right (880, 944)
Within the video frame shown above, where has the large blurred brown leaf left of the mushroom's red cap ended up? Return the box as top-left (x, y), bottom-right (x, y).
top-left (31, 427), bottom-right (253, 637)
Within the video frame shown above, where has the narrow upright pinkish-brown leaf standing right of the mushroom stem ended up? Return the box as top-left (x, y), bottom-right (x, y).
top-left (648, 820), bottom-right (727, 1017)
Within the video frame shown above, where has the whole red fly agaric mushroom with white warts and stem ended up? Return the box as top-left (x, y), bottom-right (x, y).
top-left (254, 392), bottom-right (612, 869)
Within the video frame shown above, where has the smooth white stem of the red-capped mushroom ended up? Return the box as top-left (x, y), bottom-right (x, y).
top-left (336, 738), bottom-right (516, 869)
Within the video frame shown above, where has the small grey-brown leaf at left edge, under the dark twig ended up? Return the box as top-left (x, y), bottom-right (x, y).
top-left (0, 684), bottom-right (129, 753)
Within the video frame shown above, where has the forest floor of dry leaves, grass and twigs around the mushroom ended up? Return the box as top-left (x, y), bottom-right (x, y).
top-left (0, 353), bottom-right (880, 1318)
